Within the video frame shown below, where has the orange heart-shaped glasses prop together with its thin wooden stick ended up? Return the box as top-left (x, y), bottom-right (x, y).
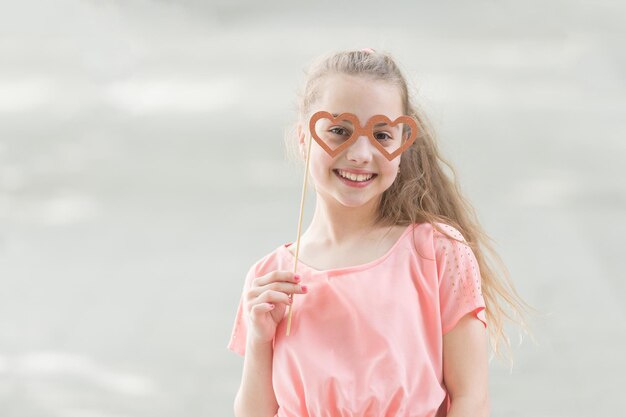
top-left (287, 111), bottom-right (418, 336)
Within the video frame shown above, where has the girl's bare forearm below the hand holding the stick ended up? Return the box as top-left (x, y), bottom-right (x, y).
top-left (235, 342), bottom-right (278, 417)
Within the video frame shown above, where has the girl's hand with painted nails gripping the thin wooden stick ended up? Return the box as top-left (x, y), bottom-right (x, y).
top-left (244, 271), bottom-right (307, 343)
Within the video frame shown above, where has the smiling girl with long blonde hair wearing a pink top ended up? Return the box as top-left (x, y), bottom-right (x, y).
top-left (228, 49), bottom-right (524, 417)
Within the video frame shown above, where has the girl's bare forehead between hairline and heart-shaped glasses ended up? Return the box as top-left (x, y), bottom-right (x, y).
top-left (313, 74), bottom-right (404, 119)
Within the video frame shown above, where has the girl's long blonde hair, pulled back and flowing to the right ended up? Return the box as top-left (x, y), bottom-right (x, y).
top-left (285, 50), bottom-right (532, 359)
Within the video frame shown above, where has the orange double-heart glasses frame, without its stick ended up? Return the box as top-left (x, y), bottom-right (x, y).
top-left (309, 111), bottom-right (417, 161)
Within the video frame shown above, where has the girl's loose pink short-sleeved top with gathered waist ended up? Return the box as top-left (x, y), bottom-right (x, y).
top-left (228, 223), bottom-right (487, 417)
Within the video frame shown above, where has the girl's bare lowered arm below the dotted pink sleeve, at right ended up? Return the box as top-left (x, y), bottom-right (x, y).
top-left (443, 314), bottom-right (490, 417)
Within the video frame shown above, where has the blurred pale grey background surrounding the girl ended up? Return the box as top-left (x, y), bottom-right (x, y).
top-left (0, 0), bottom-right (626, 417)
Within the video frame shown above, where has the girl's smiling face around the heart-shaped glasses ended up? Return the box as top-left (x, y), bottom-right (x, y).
top-left (298, 74), bottom-right (404, 207)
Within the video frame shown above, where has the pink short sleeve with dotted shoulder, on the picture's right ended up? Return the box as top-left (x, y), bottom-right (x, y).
top-left (434, 223), bottom-right (487, 334)
